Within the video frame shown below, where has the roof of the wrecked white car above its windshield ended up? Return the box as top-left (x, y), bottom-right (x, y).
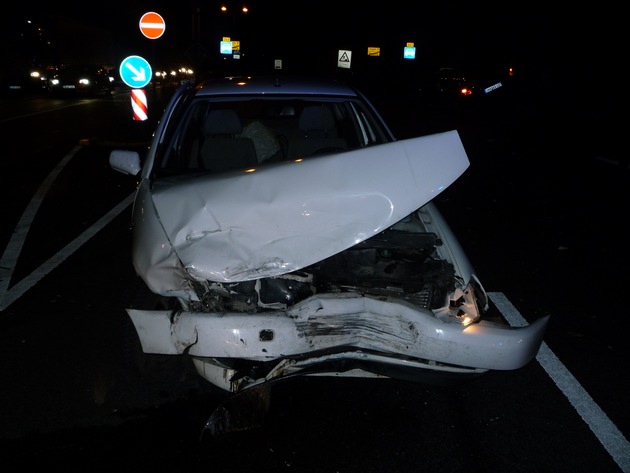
top-left (195, 76), bottom-right (358, 97)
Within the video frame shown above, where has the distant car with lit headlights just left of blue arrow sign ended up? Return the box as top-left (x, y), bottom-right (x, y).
top-left (48, 64), bottom-right (114, 95)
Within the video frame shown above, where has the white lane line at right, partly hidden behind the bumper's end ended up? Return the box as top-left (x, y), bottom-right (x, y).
top-left (488, 292), bottom-right (630, 472)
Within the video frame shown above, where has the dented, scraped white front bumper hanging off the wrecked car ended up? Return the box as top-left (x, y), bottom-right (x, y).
top-left (128, 293), bottom-right (548, 391)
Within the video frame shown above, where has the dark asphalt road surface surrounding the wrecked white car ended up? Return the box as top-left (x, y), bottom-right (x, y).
top-left (0, 83), bottom-right (630, 473)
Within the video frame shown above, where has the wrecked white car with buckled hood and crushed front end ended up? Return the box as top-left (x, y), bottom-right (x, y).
top-left (110, 77), bottom-right (547, 393)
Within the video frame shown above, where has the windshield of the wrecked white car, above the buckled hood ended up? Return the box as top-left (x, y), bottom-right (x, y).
top-left (153, 97), bottom-right (389, 177)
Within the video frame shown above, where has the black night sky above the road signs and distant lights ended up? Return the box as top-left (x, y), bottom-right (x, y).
top-left (3, 0), bottom-right (627, 90)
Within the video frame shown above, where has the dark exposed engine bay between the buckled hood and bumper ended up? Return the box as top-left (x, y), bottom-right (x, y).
top-left (191, 212), bottom-right (456, 313)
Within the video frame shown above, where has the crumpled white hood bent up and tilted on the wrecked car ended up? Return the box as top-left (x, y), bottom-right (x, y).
top-left (152, 131), bottom-right (469, 282)
